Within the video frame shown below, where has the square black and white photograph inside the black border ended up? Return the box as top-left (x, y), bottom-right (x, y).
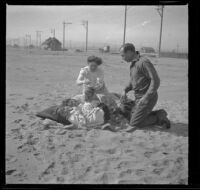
top-left (5, 4), bottom-right (189, 185)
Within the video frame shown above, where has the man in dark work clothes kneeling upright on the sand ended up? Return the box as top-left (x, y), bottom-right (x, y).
top-left (120, 43), bottom-right (170, 132)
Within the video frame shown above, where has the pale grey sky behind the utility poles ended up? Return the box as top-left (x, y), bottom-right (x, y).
top-left (6, 5), bottom-right (188, 52)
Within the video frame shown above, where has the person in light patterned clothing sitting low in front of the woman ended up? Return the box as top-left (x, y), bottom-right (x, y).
top-left (65, 87), bottom-right (110, 129)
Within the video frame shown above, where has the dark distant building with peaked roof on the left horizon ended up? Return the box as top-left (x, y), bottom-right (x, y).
top-left (41, 37), bottom-right (62, 51)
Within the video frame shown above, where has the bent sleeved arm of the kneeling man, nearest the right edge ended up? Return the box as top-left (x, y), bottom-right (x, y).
top-left (142, 60), bottom-right (160, 100)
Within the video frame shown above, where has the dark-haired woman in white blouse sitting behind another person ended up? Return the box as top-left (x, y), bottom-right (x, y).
top-left (76, 56), bottom-right (117, 108)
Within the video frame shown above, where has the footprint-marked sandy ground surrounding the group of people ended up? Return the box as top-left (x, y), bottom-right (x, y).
top-left (6, 48), bottom-right (188, 184)
